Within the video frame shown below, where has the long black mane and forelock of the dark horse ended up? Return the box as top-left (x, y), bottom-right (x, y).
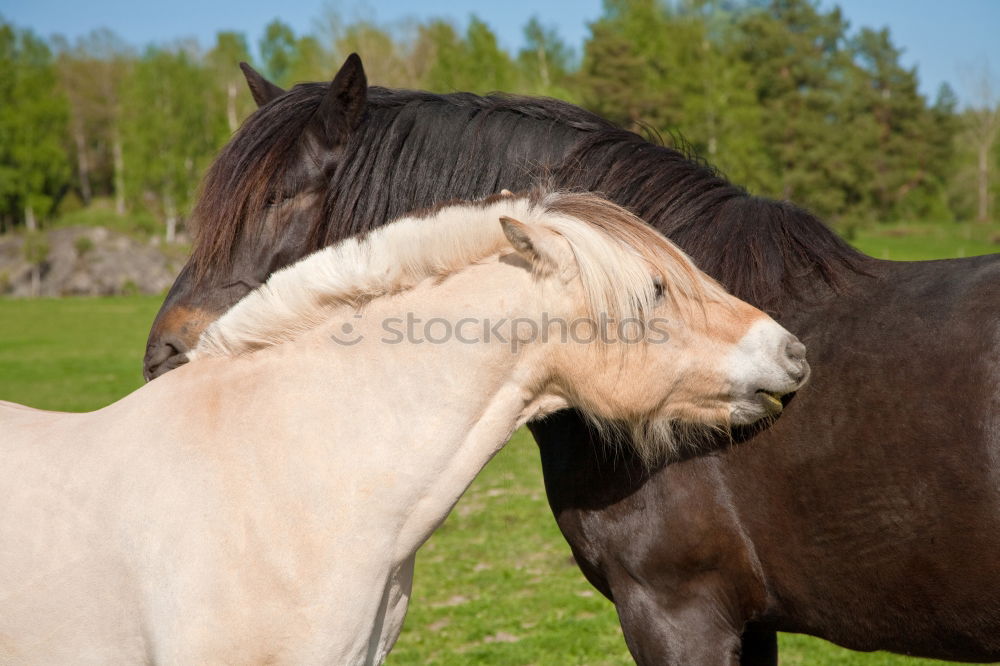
top-left (192, 83), bottom-right (862, 307)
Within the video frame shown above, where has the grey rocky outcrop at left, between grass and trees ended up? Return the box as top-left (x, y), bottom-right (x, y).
top-left (0, 227), bottom-right (183, 297)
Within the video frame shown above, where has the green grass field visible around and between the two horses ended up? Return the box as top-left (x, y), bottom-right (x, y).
top-left (0, 228), bottom-right (1000, 666)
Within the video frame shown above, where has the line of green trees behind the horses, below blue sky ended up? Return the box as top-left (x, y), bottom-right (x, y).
top-left (0, 0), bottom-right (1000, 240)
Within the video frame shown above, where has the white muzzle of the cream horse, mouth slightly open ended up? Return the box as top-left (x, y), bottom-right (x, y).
top-left (726, 317), bottom-right (809, 423)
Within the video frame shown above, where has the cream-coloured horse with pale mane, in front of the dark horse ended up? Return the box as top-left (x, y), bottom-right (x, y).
top-left (0, 193), bottom-right (808, 666)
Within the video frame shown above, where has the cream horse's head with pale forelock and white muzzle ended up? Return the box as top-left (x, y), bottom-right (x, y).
top-left (501, 193), bottom-right (809, 460)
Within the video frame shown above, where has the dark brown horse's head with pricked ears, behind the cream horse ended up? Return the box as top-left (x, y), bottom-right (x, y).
top-left (143, 55), bottom-right (367, 379)
